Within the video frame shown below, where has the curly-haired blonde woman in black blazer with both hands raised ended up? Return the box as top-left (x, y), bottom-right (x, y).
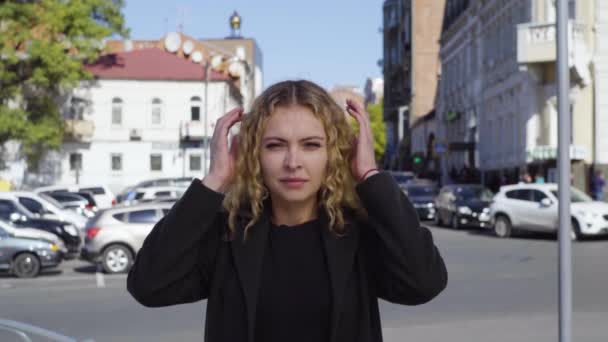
top-left (127, 81), bottom-right (447, 342)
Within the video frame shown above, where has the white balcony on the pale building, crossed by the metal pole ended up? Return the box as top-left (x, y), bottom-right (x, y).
top-left (517, 21), bottom-right (587, 64)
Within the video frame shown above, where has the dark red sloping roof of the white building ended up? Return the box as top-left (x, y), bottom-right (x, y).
top-left (85, 48), bottom-right (231, 81)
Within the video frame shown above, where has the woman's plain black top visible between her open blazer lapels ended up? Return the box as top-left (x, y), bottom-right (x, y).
top-left (255, 219), bottom-right (331, 342)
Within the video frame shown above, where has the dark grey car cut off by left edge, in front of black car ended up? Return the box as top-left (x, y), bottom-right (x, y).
top-left (0, 227), bottom-right (63, 278)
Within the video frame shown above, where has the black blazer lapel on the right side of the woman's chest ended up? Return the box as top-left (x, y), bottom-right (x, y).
top-left (320, 210), bottom-right (359, 341)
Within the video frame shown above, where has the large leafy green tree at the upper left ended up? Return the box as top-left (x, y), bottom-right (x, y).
top-left (0, 0), bottom-right (128, 169)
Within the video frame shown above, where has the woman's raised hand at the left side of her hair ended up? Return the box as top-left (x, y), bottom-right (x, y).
top-left (203, 108), bottom-right (243, 192)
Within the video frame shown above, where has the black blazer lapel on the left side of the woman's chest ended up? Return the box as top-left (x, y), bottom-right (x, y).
top-left (231, 211), bottom-right (270, 341)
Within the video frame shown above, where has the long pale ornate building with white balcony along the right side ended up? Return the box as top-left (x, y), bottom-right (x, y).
top-left (437, 0), bottom-right (608, 194)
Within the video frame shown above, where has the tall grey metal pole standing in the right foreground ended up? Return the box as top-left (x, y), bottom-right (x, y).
top-left (556, 0), bottom-right (572, 342)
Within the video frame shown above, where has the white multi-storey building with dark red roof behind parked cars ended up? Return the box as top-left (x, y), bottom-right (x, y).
top-left (51, 48), bottom-right (242, 195)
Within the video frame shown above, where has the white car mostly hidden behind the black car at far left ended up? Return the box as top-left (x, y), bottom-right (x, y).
top-left (8, 191), bottom-right (87, 229)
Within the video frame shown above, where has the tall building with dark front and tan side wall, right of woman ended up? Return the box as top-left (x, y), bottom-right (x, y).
top-left (382, 0), bottom-right (445, 169)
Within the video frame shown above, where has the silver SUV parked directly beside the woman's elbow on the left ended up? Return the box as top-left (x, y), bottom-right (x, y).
top-left (81, 203), bottom-right (172, 273)
